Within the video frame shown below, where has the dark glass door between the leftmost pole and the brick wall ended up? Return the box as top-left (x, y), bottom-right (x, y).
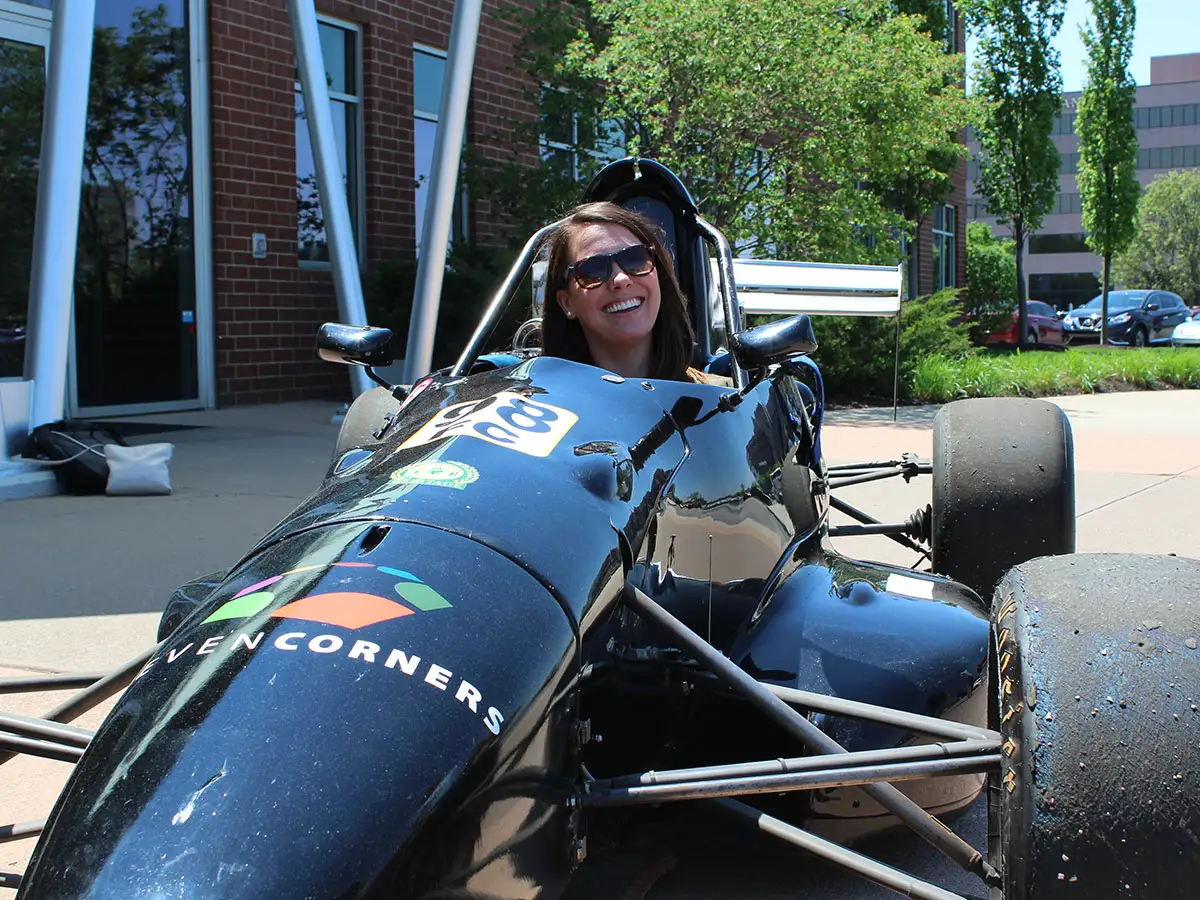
top-left (68, 0), bottom-right (202, 415)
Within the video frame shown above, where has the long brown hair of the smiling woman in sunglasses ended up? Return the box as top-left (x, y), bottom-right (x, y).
top-left (541, 203), bottom-right (696, 380)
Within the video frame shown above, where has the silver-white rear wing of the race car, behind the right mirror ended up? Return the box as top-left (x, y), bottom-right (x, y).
top-left (714, 259), bottom-right (904, 316)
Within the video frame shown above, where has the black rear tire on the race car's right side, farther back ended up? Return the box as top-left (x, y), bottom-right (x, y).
top-left (930, 397), bottom-right (1075, 598)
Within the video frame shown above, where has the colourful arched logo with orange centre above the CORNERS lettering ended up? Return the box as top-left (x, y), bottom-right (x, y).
top-left (202, 563), bottom-right (452, 629)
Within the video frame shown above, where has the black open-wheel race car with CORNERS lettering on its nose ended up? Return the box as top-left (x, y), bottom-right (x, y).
top-left (7, 160), bottom-right (1200, 900)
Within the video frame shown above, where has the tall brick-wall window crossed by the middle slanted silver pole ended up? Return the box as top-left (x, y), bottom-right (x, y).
top-left (295, 17), bottom-right (362, 263)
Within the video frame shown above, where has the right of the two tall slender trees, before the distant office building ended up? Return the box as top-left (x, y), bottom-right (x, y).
top-left (1075, 0), bottom-right (1141, 343)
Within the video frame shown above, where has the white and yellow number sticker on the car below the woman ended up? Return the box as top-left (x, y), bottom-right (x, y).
top-left (400, 391), bottom-right (580, 456)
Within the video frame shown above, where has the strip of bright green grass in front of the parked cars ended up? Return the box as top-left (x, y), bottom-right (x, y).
top-left (911, 346), bottom-right (1200, 403)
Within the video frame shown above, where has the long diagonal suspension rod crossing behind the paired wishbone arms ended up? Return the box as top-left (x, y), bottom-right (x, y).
top-left (625, 582), bottom-right (998, 882)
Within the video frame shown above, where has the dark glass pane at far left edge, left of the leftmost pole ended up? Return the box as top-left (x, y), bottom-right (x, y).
top-left (0, 2), bottom-right (50, 380)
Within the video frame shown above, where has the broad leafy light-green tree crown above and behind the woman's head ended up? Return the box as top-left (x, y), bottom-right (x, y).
top-left (472, 0), bottom-right (970, 262)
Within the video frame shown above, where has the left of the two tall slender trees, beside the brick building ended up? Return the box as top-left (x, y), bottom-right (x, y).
top-left (962, 0), bottom-right (1066, 346)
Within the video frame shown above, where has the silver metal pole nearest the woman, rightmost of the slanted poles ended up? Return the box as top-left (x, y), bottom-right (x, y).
top-left (404, 0), bottom-right (484, 384)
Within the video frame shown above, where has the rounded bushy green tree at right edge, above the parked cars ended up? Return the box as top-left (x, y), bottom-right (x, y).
top-left (1112, 170), bottom-right (1200, 305)
